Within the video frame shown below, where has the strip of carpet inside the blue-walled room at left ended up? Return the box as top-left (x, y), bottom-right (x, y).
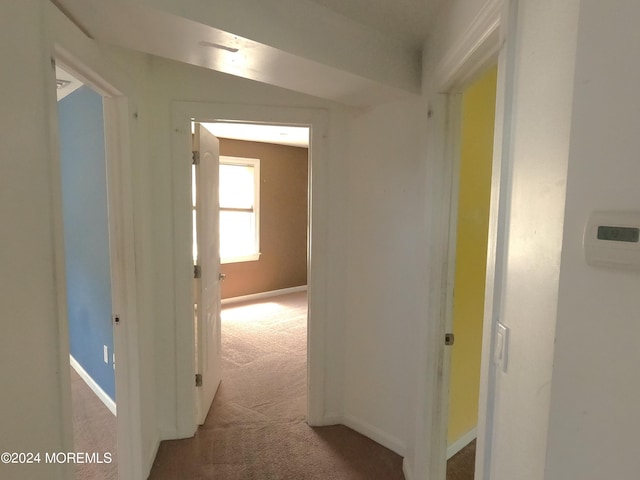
top-left (71, 368), bottom-right (118, 480)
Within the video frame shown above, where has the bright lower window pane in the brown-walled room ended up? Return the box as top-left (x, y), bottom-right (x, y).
top-left (220, 210), bottom-right (257, 259)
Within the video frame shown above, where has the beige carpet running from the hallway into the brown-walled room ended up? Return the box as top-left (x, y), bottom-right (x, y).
top-left (149, 293), bottom-right (404, 480)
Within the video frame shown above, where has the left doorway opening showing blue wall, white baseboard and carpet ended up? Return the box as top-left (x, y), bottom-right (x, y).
top-left (56, 67), bottom-right (118, 479)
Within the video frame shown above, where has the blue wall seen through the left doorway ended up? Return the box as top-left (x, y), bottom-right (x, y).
top-left (58, 87), bottom-right (115, 400)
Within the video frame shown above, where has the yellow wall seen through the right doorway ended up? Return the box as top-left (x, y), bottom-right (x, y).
top-left (448, 68), bottom-right (497, 445)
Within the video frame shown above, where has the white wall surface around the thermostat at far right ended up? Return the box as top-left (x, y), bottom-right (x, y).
top-left (545, 0), bottom-right (640, 480)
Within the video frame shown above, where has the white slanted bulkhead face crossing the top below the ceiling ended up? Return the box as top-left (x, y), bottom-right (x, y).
top-left (141, 0), bottom-right (420, 92)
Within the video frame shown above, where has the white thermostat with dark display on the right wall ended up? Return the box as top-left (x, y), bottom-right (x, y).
top-left (583, 212), bottom-right (640, 270)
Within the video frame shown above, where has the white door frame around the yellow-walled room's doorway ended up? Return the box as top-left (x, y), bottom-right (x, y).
top-left (425, 0), bottom-right (517, 480)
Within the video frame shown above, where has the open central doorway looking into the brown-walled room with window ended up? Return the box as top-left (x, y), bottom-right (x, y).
top-left (212, 124), bottom-right (309, 432)
